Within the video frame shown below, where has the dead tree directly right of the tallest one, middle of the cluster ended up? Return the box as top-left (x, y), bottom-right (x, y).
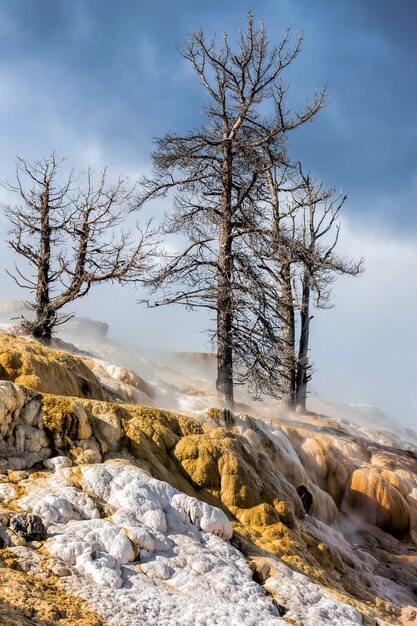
top-left (232, 158), bottom-right (300, 407)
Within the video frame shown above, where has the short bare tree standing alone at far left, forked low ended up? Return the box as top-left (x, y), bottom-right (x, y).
top-left (3, 154), bottom-right (155, 343)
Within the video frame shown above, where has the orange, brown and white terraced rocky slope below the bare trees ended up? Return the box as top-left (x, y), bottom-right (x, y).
top-left (0, 334), bottom-right (417, 626)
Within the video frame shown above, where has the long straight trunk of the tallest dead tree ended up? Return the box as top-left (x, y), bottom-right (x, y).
top-left (216, 142), bottom-right (234, 409)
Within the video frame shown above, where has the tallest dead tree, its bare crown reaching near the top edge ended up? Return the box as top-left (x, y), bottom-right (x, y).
top-left (142, 13), bottom-right (325, 407)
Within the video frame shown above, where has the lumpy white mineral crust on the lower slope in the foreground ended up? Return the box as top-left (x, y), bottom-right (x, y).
top-left (20, 462), bottom-right (282, 626)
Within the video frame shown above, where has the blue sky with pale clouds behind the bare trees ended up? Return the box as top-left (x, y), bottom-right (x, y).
top-left (0, 0), bottom-right (417, 423)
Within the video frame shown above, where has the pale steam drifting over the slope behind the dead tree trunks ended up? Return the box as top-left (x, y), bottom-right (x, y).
top-left (22, 309), bottom-right (410, 446)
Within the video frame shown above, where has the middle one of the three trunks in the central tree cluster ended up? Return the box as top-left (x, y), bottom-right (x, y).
top-left (281, 256), bottom-right (297, 409)
